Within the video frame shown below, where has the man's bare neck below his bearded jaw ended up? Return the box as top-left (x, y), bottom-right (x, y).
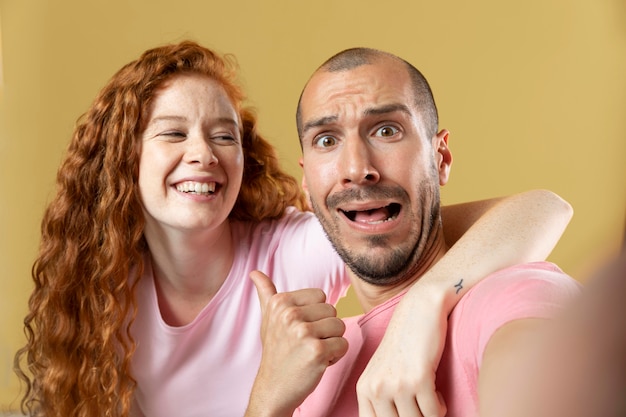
top-left (349, 234), bottom-right (448, 313)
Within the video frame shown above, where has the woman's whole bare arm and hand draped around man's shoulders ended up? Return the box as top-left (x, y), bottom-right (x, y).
top-left (357, 190), bottom-right (573, 416)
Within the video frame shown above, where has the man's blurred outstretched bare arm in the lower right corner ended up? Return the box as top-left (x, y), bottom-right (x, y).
top-left (488, 250), bottom-right (626, 417)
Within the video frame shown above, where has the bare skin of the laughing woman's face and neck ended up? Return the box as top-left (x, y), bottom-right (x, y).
top-left (139, 75), bottom-right (244, 325)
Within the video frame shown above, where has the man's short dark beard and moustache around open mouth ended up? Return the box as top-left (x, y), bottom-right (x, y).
top-left (311, 178), bottom-right (440, 286)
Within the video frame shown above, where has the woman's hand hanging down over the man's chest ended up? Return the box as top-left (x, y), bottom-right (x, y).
top-left (357, 290), bottom-right (448, 417)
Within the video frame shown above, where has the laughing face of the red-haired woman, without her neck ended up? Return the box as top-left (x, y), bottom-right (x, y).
top-left (139, 74), bottom-right (244, 234)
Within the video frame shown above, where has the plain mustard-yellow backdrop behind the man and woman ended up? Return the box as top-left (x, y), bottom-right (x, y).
top-left (0, 0), bottom-right (626, 411)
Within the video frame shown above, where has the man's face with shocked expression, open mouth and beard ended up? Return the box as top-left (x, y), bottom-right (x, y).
top-left (301, 59), bottom-right (451, 285)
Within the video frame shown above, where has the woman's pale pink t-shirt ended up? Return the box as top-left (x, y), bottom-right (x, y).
top-left (132, 210), bottom-right (349, 417)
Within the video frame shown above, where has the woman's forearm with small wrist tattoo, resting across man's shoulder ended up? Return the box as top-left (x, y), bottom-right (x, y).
top-left (401, 190), bottom-right (572, 314)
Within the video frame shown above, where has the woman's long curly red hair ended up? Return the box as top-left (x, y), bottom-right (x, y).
top-left (15, 41), bottom-right (306, 417)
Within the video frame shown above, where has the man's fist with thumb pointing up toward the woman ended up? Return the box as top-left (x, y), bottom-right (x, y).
top-left (246, 271), bottom-right (348, 417)
